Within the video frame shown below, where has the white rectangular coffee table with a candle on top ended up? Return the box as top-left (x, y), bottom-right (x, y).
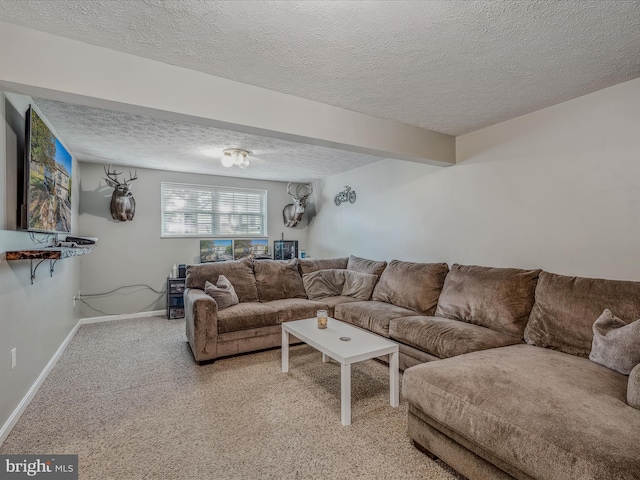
top-left (282, 317), bottom-right (400, 425)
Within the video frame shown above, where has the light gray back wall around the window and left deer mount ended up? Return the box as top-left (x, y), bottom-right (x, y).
top-left (80, 160), bottom-right (313, 317)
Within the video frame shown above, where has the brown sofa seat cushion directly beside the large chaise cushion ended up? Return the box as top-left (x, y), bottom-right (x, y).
top-left (389, 316), bottom-right (522, 358)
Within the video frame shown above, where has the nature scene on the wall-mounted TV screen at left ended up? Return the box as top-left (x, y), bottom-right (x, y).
top-left (27, 108), bottom-right (72, 232)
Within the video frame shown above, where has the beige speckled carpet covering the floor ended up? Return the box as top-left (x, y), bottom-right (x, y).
top-left (0, 317), bottom-right (462, 480)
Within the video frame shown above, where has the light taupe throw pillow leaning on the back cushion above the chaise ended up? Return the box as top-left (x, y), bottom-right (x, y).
top-left (589, 309), bottom-right (640, 375)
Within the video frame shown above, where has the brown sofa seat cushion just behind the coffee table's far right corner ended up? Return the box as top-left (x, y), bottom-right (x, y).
top-left (334, 300), bottom-right (416, 337)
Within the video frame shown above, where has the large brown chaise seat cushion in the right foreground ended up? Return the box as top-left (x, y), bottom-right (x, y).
top-left (403, 345), bottom-right (640, 480)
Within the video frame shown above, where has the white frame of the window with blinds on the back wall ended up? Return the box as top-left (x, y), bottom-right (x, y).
top-left (160, 182), bottom-right (268, 238)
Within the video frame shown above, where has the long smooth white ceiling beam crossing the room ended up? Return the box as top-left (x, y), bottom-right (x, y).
top-left (0, 22), bottom-right (455, 166)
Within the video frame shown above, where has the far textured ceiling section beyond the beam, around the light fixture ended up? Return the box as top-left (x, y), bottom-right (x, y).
top-left (34, 98), bottom-right (380, 182)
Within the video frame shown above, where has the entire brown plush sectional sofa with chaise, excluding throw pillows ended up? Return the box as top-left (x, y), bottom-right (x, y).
top-left (185, 256), bottom-right (640, 480)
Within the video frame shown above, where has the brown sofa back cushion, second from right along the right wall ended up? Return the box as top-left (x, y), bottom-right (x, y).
top-left (435, 263), bottom-right (540, 339)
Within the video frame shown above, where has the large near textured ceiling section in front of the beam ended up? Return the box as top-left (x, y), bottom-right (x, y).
top-left (0, 0), bottom-right (640, 175)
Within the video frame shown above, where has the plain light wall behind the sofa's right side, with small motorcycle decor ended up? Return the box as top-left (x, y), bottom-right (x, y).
top-left (309, 79), bottom-right (640, 282)
